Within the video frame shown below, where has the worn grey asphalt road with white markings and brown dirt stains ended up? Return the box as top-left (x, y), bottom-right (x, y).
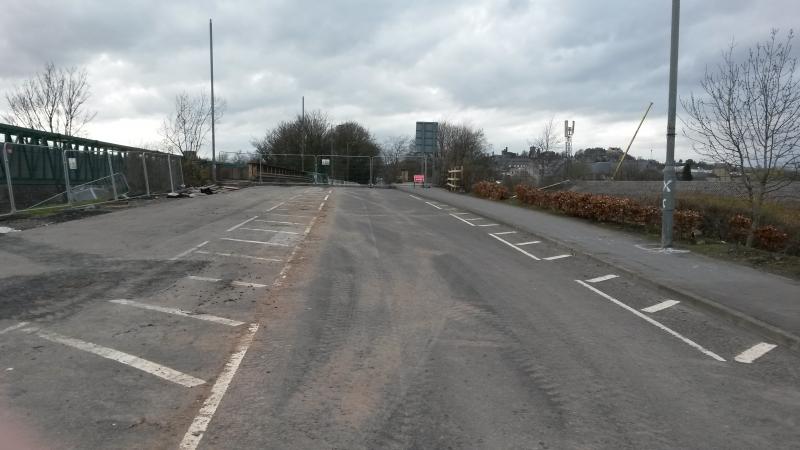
top-left (0, 187), bottom-right (800, 449)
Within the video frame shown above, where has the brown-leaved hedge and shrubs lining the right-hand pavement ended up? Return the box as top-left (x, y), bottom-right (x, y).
top-left (472, 181), bottom-right (800, 279)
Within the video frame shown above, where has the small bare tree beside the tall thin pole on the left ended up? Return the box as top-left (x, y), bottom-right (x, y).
top-left (160, 91), bottom-right (225, 155)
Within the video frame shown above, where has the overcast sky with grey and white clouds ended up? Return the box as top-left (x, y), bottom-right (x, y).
top-left (0, 0), bottom-right (800, 160)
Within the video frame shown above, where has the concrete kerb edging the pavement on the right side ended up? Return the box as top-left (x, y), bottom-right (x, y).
top-left (406, 188), bottom-right (800, 351)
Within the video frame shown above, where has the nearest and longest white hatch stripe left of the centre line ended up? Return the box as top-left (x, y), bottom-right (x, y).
top-left (36, 331), bottom-right (205, 387)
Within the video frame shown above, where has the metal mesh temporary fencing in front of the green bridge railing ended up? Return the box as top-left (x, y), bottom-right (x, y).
top-left (0, 143), bottom-right (183, 215)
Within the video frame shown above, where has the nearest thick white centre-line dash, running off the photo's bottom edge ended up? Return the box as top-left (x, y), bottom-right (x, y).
top-left (180, 323), bottom-right (258, 450)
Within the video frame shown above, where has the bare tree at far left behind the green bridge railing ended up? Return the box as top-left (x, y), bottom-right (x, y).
top-left (3, 62), bottom-right (97, 136)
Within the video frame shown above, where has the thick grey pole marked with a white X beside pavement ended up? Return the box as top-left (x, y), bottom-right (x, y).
top-left (661, 0), bottom-right (681, 249)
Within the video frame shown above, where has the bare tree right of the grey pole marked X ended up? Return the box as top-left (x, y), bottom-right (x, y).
top-left (682, 30), bottom-right (800, 247)
